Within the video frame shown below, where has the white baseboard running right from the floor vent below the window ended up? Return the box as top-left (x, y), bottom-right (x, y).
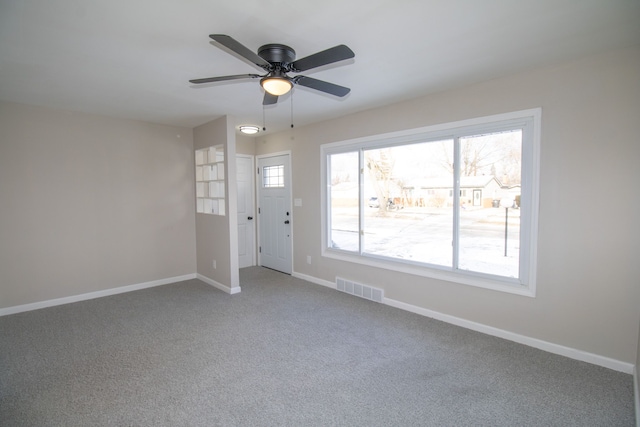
top-left (383, 298), bottom-right (634, 374)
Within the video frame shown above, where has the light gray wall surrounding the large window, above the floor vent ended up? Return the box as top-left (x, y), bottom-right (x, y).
top-left (256, 47), bottom-right (640, 364)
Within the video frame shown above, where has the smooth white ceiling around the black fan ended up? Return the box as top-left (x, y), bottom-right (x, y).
top-left (0, 0), bottom-right (640, 132)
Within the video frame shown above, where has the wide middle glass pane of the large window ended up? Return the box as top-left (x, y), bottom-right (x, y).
top-left (363, 140), bottom-right (453, 267)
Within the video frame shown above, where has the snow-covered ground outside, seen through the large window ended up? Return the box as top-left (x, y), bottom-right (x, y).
top-left (331, 207), bottom-right (520, 277)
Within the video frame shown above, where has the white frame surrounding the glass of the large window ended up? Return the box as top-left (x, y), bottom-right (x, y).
top-left (320, 108), bottom-right (542, 297)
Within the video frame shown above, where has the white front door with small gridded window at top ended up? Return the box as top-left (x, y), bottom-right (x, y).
top-left (258, 154), bottom-right (293, 274)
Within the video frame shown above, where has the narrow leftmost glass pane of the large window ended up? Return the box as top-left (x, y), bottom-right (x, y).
top-left (329, 152), bottom-right (360, 252)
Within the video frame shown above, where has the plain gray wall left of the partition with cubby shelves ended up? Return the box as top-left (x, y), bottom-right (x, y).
top-left (0, 103), bottom-right (195, 308)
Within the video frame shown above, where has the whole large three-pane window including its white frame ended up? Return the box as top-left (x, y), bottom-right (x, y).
top-left (322, 109), bottom-right (540, 295)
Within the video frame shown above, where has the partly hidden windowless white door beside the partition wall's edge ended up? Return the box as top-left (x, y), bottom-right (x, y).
top-left (236, 155), bottom-right (256, 268)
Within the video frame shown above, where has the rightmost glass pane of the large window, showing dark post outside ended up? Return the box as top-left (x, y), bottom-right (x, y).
top-left (458, 130), bottom-right (522, 277)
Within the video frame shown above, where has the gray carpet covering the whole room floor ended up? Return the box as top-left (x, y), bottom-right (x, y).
top-left (0, 267), bottom-right (635, 426)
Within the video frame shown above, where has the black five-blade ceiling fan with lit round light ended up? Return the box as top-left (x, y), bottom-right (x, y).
top-left (189, 34), bottom-right (355, 105)
